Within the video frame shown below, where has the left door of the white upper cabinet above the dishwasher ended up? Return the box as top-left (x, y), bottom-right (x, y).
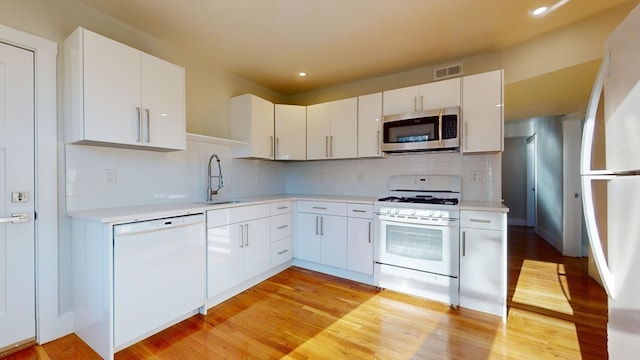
top-left (83, 30), bottom-right (143, 145)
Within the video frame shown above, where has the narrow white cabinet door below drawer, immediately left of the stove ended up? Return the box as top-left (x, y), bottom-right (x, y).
top-left (347, 218), bottom-right (373, 275)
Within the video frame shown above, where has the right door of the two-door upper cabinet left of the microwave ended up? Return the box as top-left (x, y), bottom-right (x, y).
top-left (329, 97), bottom-right (358, 159)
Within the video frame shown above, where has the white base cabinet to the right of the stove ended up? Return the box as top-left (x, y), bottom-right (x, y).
top-left (460, 210), bottom-right (507, 319)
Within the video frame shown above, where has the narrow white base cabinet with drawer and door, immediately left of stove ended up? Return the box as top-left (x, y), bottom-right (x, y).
top-left (347, 204), bottom-right (373, 275)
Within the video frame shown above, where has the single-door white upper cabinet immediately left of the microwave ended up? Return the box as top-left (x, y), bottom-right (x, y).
top-left (358, 93), bottom-right (382, 157)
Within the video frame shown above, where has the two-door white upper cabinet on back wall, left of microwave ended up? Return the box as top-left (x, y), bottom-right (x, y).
top-left (307, 97), bottom-right (358, 160)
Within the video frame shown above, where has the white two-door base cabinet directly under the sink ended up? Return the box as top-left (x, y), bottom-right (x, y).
top-left (207, 204), bottom-right (271, 297)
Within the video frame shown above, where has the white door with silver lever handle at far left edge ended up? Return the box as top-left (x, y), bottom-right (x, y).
top-left (0, 43), bottom-right (35, 353)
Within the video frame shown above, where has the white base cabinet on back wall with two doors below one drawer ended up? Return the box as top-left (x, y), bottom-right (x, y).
top-left (295, 201), bottom-right (347, 269)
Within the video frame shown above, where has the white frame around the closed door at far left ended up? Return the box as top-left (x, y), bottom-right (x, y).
top-left (0, 24), bottom-right (67, 343)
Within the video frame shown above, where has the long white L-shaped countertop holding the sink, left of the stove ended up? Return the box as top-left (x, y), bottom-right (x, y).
top-left (67, 194), bottom-right (376, 224)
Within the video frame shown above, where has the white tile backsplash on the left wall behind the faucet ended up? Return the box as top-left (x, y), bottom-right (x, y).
top-left (66, 140), bottom-right (286, 211)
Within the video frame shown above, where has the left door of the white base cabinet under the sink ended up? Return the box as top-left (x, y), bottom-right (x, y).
top-left (207, 223), bottom-right (244, 297)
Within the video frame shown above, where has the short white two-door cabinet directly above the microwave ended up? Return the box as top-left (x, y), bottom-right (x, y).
top-left (382, 78), bottom-right (461, 115)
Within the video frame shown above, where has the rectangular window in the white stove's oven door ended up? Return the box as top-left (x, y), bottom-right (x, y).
top-left (386, 225), bottom-right (443, 261)
